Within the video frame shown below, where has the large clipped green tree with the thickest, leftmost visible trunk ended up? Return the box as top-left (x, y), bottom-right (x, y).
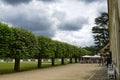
top-left (9, 27), bottom-right (37, 71)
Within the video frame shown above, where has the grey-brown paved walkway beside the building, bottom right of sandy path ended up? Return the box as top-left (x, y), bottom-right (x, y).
top-left (89, 67), bottom-right (108, 80)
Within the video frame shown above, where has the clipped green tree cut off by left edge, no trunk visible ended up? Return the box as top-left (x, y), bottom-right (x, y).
top-left (0, 22), bottom-right (12, 58)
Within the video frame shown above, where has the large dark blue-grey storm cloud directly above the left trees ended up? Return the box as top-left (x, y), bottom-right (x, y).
top-left (2, 12), bottom-right (55, 37)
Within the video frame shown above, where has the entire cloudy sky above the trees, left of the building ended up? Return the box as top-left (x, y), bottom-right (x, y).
top-left (0, 0), bottom-right (107, 47)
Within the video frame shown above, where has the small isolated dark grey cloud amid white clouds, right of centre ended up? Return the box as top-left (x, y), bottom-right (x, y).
top-left (59, 18), bottom-right (88, 31)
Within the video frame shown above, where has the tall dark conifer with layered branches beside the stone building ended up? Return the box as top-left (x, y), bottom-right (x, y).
top-left (92, 12), bottom-right (109, 50)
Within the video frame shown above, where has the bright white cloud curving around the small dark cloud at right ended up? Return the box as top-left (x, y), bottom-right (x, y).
top-left (53, 1), bottom-right (107, 47)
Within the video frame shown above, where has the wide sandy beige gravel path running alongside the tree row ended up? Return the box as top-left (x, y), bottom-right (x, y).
top-left (0, 63), bottom-right (100, 80)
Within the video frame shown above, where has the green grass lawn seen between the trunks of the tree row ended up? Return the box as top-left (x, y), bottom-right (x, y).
top-left (0, 62), bottom-right (67, 74)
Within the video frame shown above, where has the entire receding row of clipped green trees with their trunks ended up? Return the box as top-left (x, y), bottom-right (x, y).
top-left (0, 23), bottom-right (90, 71)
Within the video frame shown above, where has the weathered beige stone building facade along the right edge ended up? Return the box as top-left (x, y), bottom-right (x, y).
top-left (108, 0), bottom-right (120, 80)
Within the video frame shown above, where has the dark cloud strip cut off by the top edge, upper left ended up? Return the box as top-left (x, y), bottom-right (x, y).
top-left (2, 0), bottom-right (32, 5)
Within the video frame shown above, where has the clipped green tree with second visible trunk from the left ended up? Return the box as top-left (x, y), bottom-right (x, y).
top-left (36, 36), bottom-right (51, 68)
